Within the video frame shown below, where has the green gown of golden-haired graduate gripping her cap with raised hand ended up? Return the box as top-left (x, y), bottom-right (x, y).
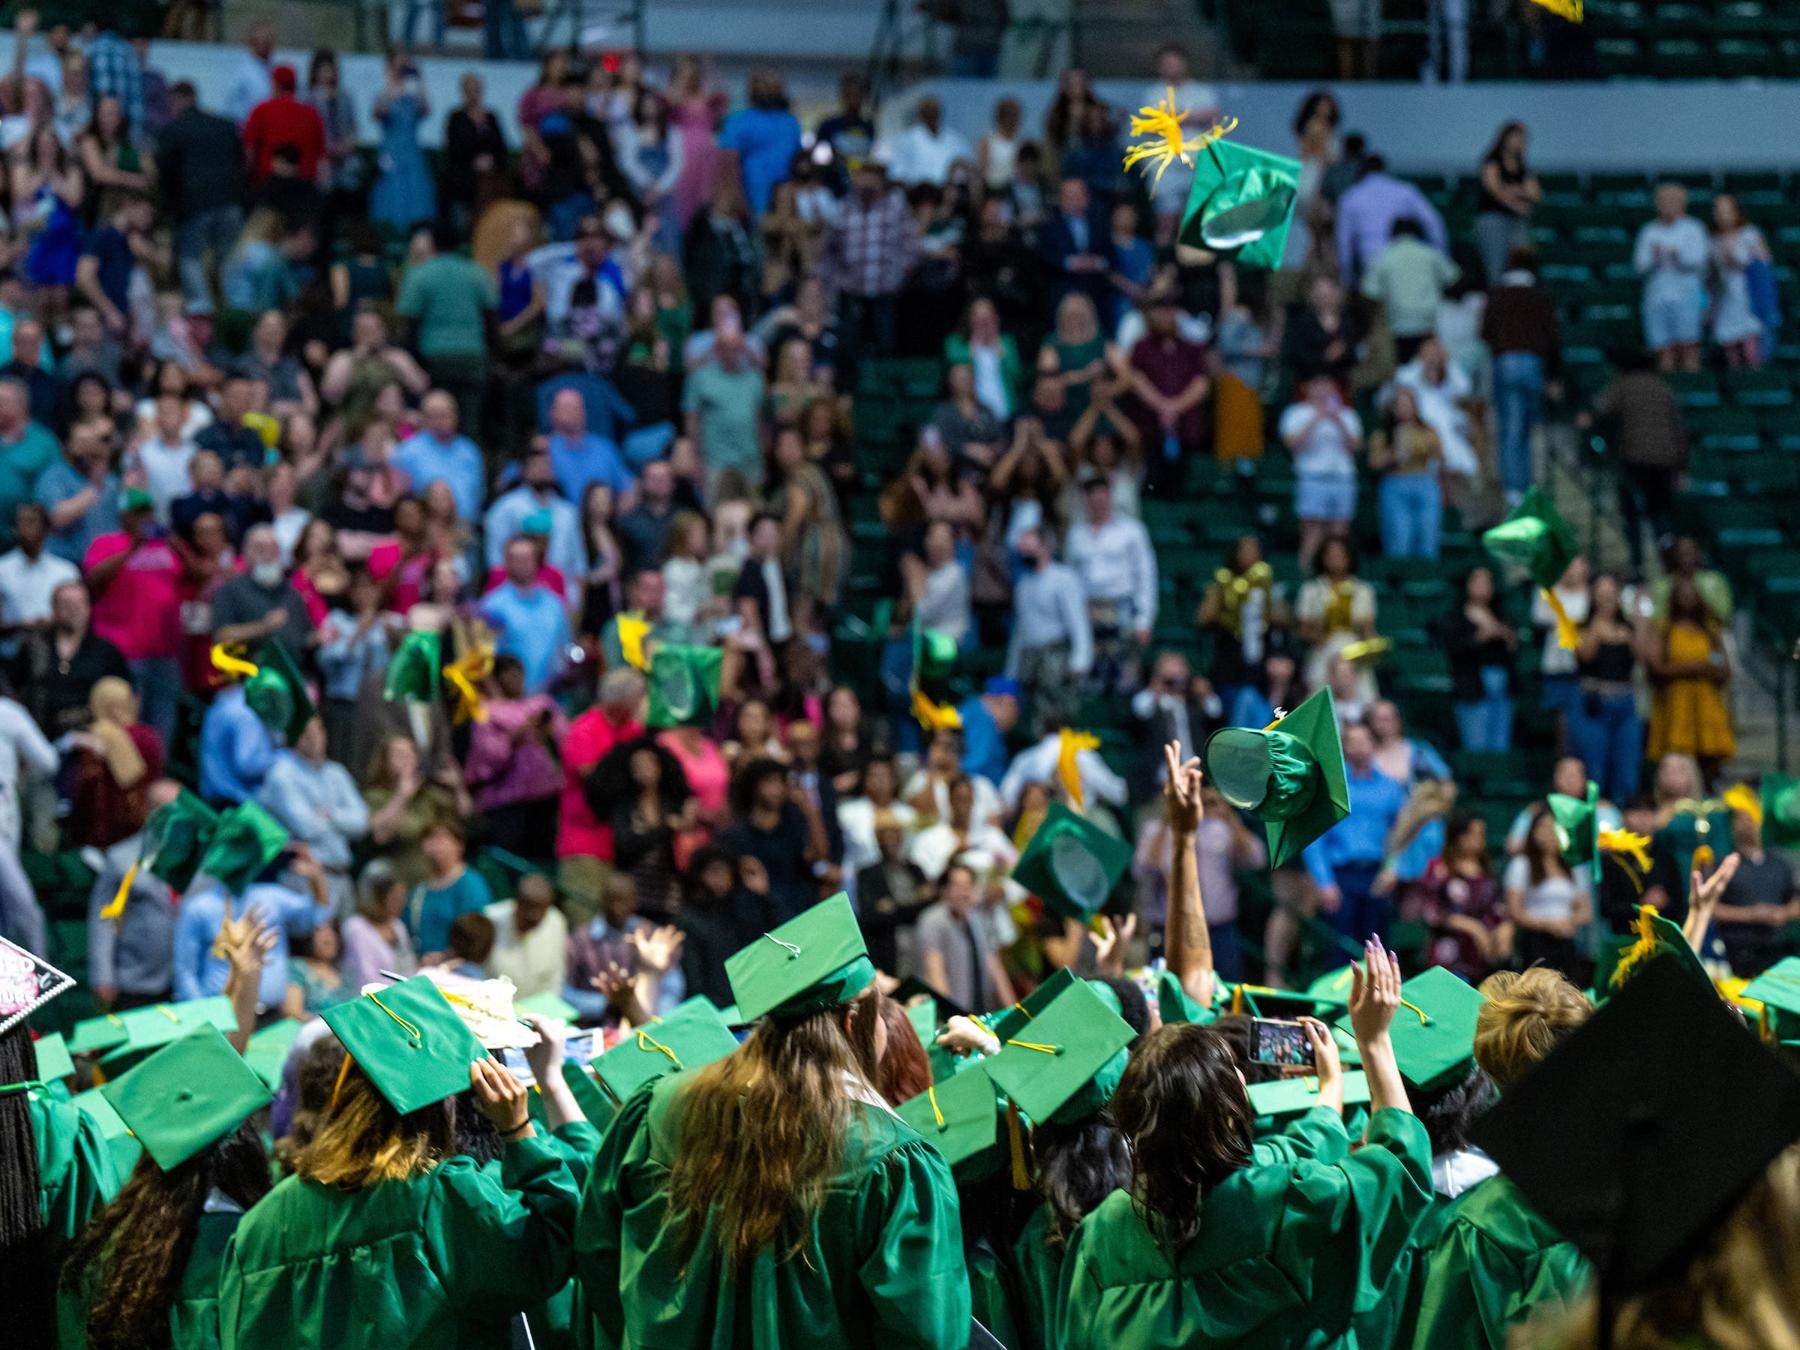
top-left (220, 1138), bottom-right (578, 1350)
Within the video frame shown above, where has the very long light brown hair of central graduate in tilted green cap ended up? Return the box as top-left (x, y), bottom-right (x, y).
top-left (670, 990), bottom-right (882, 1271)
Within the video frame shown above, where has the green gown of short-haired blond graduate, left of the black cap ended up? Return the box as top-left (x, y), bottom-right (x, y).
top-left (1413, 1175), bottom-right (1591, 1350)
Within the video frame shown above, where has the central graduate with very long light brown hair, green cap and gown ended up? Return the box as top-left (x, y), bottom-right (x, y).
top-left (574, 895), bottom-right (970, 1350)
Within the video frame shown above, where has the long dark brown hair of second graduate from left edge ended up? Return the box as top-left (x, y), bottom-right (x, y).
top-left (63, 1121), bottom-right (270, 1350)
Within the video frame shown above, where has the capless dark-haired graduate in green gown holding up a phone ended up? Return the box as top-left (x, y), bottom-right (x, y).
top-left (1058, 940), bottom-right (1431, 1350)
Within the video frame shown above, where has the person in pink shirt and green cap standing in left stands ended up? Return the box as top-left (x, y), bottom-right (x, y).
top-left (81, 488), bottom-right (182, 745)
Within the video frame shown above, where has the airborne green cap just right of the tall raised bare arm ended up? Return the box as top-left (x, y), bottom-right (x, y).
top-left (1201, 689), bottom-right (1350, 868)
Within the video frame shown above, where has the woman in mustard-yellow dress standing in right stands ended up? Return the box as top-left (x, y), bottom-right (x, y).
top-left (1643, 581), bottom-right (1737, 783)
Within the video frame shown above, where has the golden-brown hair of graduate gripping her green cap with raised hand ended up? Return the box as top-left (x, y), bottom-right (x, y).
top-left (293, 1062), bottom-right (455, 1190)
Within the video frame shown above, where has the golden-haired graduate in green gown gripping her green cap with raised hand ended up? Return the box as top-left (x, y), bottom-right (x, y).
top-left (220, 976), bottom-right (578, 1350)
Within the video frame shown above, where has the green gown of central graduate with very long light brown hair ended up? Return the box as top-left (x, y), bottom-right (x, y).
top-left (576, 1073), bottom-right (970, 1350)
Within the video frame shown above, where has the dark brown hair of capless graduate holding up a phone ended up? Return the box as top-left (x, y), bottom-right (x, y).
top-left (1112, 1024), bottom-right (1253, 1251)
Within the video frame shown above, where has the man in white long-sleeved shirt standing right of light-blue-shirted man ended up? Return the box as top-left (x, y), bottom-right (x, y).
top-left (1062, 473), bottom-right (1157, 688)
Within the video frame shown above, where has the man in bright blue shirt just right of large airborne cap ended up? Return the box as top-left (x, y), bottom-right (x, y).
top-left (1303, 722), bottom-right (1406, 965)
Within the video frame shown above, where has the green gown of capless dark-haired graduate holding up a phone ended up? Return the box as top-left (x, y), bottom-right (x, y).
top-left (1060, 1111), bottom-right (1431, 1350)
